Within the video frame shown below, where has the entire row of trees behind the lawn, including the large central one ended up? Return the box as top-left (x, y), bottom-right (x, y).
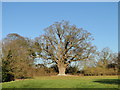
top-left (0, 21), bottom-right (119, 82)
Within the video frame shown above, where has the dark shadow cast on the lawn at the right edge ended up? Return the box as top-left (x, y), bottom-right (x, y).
top-left (93, 79), bottom-right (120, 85)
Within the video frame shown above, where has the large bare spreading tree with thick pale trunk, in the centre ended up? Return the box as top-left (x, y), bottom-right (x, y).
top-left (36, 21), bottom-right (95, 75)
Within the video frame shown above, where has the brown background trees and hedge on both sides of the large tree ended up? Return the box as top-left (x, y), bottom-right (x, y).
top-left (1, 34), bottom-right (119, 82)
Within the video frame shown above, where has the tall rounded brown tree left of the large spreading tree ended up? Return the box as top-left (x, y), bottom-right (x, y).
top-left (2, 33), bottom-right (35, 78)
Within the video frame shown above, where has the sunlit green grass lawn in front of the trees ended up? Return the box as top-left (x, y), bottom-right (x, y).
top-left (2, 76), bottom-right (120, 88)
